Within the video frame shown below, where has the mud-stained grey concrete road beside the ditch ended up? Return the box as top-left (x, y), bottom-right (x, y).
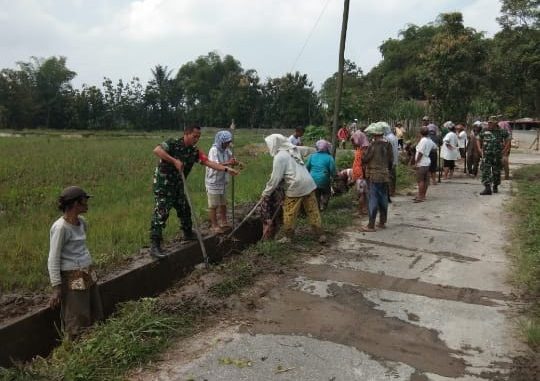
top-left (134, 153), bottom-right (540, 381)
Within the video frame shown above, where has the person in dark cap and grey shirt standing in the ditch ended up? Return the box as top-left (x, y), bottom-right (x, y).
top-left (47, 186), bottom-right (103, 338)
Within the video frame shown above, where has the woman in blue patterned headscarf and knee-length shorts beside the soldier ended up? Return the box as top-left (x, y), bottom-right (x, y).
top-left (204, 131), bottom-right (237, 234)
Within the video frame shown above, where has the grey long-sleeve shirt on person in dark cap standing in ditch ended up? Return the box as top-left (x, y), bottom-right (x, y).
top-left (47, 216), bottom-right (92, 287)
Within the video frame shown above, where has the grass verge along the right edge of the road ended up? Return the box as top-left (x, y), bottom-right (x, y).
top-left (512, 165), bottom-right (540, 349)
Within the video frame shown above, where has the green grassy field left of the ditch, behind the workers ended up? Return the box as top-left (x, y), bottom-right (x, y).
top-left (0, 131), bottom-right (271, 291)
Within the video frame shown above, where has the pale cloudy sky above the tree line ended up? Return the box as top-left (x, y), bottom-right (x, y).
top-left (0, 0), bottom-right (500, 88)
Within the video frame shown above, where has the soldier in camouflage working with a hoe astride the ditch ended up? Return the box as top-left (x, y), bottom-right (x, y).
top-left (150, 126), bottom-right (238, 258)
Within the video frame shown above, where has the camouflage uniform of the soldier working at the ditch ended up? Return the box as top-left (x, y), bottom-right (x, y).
top-left (150, 138), bottom-right (200, 241)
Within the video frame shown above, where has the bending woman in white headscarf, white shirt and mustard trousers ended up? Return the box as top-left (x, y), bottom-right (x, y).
top-left (262, 134), bottom-right (326, 243)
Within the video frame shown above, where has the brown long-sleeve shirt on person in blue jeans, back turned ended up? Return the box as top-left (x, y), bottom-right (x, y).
top-left (362, 140), bottom-right (394, 183)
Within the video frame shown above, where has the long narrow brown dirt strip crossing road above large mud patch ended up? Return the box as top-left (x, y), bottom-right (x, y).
top-left (303, 265), bottom-right (508, 306)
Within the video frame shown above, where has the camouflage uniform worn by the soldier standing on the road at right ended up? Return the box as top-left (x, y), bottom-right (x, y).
top-left (479, 128), bottom-right (510, 186)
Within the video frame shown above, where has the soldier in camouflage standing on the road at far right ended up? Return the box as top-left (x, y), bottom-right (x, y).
top-left (477, 118), bottom-right (510, 195)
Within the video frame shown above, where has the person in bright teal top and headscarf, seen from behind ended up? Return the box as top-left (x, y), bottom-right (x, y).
top-left (306, 139), bottom-right (336, 211)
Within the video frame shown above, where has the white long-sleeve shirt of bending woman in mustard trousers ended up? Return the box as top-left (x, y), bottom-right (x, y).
top-left (262, 151), bottom-right (317, 197)
